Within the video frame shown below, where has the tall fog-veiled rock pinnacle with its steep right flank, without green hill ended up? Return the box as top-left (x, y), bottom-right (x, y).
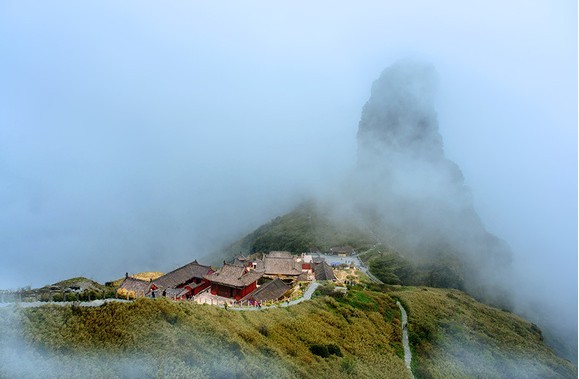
top-left (351, 61), bottom-right (511, 305)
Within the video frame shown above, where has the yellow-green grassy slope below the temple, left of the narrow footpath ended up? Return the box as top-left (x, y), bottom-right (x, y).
top-left (14, 291), bottom-right (407, 378)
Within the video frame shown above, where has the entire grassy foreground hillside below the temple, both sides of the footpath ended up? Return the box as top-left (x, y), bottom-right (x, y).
top-left (0, 286), bottom-right (577, 378)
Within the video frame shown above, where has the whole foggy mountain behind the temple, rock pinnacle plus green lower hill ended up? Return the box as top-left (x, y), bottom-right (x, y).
top-left (221, 61), bottom-right (511, 306)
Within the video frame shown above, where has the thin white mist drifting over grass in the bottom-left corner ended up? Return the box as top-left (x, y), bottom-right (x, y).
top-left (0, 305), bottom-right (289, 378)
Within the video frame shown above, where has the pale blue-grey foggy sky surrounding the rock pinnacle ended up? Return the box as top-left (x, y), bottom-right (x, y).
top-left (0, 1), bottom-right (577, 332)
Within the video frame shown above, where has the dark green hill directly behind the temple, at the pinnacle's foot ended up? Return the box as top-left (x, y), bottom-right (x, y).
top-left (220, 202), bottom-right (464, 290)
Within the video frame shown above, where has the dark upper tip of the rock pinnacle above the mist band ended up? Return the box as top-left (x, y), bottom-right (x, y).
top-left (358, 59), bottom-right (444, 163)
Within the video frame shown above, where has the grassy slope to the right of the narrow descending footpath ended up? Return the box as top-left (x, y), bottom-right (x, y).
top-left (397, 288), bottom-right (577, 378)
